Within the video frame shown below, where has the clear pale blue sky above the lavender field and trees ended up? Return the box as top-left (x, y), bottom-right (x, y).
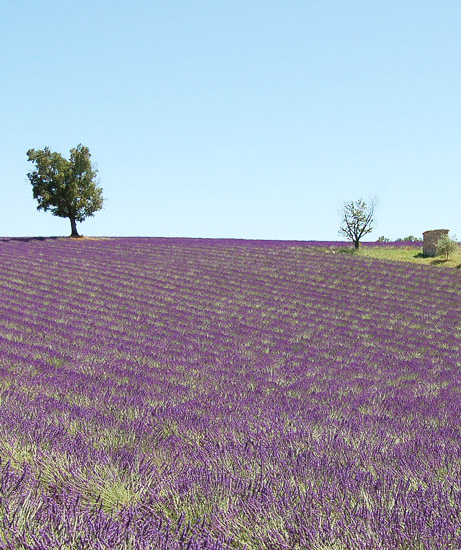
top-left (0, 0), bottom-right (461, 240)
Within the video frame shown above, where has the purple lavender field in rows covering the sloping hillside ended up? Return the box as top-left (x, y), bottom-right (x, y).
top-left (0, 238), bottom-right (461, 550)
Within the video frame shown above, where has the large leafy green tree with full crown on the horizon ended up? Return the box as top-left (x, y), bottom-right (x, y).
top-left (27, 144), bottom-right (103, 237)
